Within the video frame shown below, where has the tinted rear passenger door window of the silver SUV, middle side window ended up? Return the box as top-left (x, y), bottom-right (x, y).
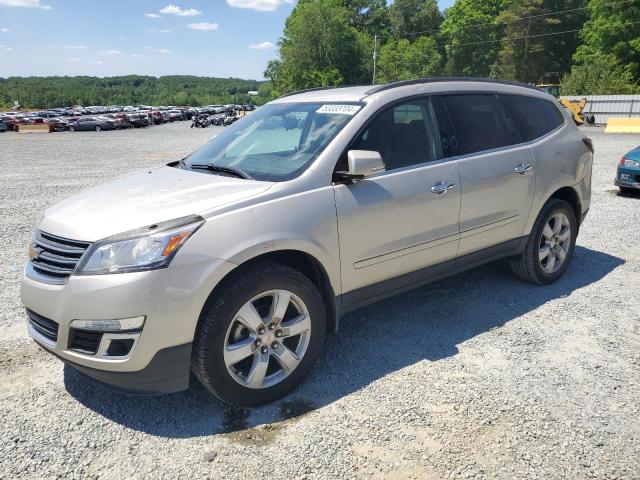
top-left (442, 94), bottom-right (513, 155)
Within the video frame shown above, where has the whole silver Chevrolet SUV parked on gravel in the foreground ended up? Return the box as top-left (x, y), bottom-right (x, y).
top-left (22, 79), bottom-right (593, 405)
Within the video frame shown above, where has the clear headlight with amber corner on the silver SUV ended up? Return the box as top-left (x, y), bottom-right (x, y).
top-left (76, 216), bottom-right (204, 275)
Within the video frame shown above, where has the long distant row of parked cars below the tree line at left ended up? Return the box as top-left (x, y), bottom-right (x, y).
top-left (0, 105), bottom-right (255, 132)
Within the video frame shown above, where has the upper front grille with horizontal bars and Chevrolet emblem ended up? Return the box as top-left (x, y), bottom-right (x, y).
top-left (30, 230), bottom-right (91, 281)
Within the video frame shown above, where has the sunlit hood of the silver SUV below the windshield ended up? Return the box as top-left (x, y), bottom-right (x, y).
top-left (39, 167), bottom-right (272, 242)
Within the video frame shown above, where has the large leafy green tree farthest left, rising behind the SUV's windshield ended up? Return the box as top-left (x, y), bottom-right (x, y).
top-left (265, 0), bottom-right (371, 95)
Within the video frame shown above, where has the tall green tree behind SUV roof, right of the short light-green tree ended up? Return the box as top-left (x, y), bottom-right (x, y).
top-left (441, 0), bottom-right (505, 77)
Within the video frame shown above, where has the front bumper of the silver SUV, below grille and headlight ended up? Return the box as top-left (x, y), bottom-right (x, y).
top-left (21, 255), bottom-right (234, 394)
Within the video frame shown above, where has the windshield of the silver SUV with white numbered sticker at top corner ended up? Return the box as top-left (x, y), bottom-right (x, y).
top-left (184, 103), bottom-right (361, 182)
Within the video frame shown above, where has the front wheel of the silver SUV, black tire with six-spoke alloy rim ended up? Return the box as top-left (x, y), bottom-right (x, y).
top-left (192, 262), bottom-right (326, 406)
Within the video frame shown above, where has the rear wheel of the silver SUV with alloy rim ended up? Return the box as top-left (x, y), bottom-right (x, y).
top-left (511, 198), bottom-right (578, 285)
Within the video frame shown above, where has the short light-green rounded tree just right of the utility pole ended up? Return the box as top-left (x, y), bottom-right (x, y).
top-left (378, 36), bottom-right (442, 82)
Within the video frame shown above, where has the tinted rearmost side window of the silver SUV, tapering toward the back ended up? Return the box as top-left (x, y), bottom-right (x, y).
top-left (500, 95), bottom-right (564, 142)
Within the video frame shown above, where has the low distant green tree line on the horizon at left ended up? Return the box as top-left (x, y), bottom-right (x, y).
top-left (0, 75), bottom-right (271, 108)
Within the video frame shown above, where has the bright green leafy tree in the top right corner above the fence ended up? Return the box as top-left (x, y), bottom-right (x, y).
top-left (573, 0), bottom-right (640, 82)
